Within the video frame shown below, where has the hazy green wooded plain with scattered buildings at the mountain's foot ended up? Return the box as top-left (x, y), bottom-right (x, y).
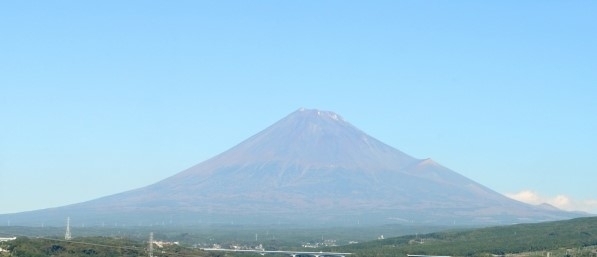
top-left (0, 224), bottom-right (453, 250)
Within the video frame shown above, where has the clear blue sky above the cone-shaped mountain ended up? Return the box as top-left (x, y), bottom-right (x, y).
top-left (0, 0), bottom-right (597, 213)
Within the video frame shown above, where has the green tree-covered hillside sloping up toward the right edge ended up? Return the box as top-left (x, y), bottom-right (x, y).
top-left (334, 217), bottom-right (597, 257)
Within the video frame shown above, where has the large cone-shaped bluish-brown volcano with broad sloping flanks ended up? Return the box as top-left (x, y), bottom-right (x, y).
top-left (0, 109), bottom-right (580, 225)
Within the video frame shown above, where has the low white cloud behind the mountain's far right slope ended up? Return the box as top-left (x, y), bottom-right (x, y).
top-left (505, 189), bottom-right (597, 213)
